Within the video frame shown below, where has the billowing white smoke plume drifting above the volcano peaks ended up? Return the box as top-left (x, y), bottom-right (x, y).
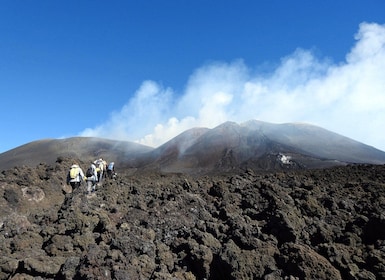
top-left (82, 23), bottom-right (385, 150)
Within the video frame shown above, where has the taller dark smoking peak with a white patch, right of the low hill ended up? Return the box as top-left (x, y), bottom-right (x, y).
top-left (143, 120), bottom-right (385, 172)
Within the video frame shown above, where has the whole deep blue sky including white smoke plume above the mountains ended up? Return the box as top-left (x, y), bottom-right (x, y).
top-left (0, 0), bottom-right (385, 153)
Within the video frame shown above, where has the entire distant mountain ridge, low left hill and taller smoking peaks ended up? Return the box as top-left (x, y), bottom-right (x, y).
top-left (0, 120), bottom-right (385, 173)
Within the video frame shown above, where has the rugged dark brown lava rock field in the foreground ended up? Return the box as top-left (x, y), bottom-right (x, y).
top-left (0, 156), bottom-right (385, 280)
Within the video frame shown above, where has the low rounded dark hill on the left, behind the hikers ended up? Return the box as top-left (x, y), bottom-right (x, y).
top-left (0, 137), bottom-right (153, 170)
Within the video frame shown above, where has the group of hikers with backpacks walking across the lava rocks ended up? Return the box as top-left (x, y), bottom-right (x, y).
top-left (67, 158), bottom-right (116, 194)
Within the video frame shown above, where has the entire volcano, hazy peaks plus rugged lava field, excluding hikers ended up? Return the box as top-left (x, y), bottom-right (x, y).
top-left (0, 120), bottom-right (385, 280)
